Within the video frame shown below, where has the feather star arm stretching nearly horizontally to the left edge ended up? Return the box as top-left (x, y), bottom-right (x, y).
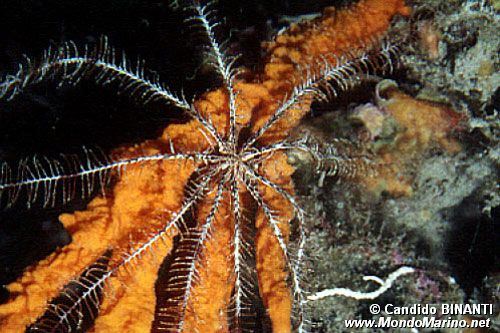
top-left (0, 148), bottom-right (213, 208)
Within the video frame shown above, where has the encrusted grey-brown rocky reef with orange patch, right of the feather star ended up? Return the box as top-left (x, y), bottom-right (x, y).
top-left (297, 0), bottom-right (500, 332)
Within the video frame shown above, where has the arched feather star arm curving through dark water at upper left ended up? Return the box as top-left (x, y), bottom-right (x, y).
top-left (0, 37), bottom-right (190, 110)
